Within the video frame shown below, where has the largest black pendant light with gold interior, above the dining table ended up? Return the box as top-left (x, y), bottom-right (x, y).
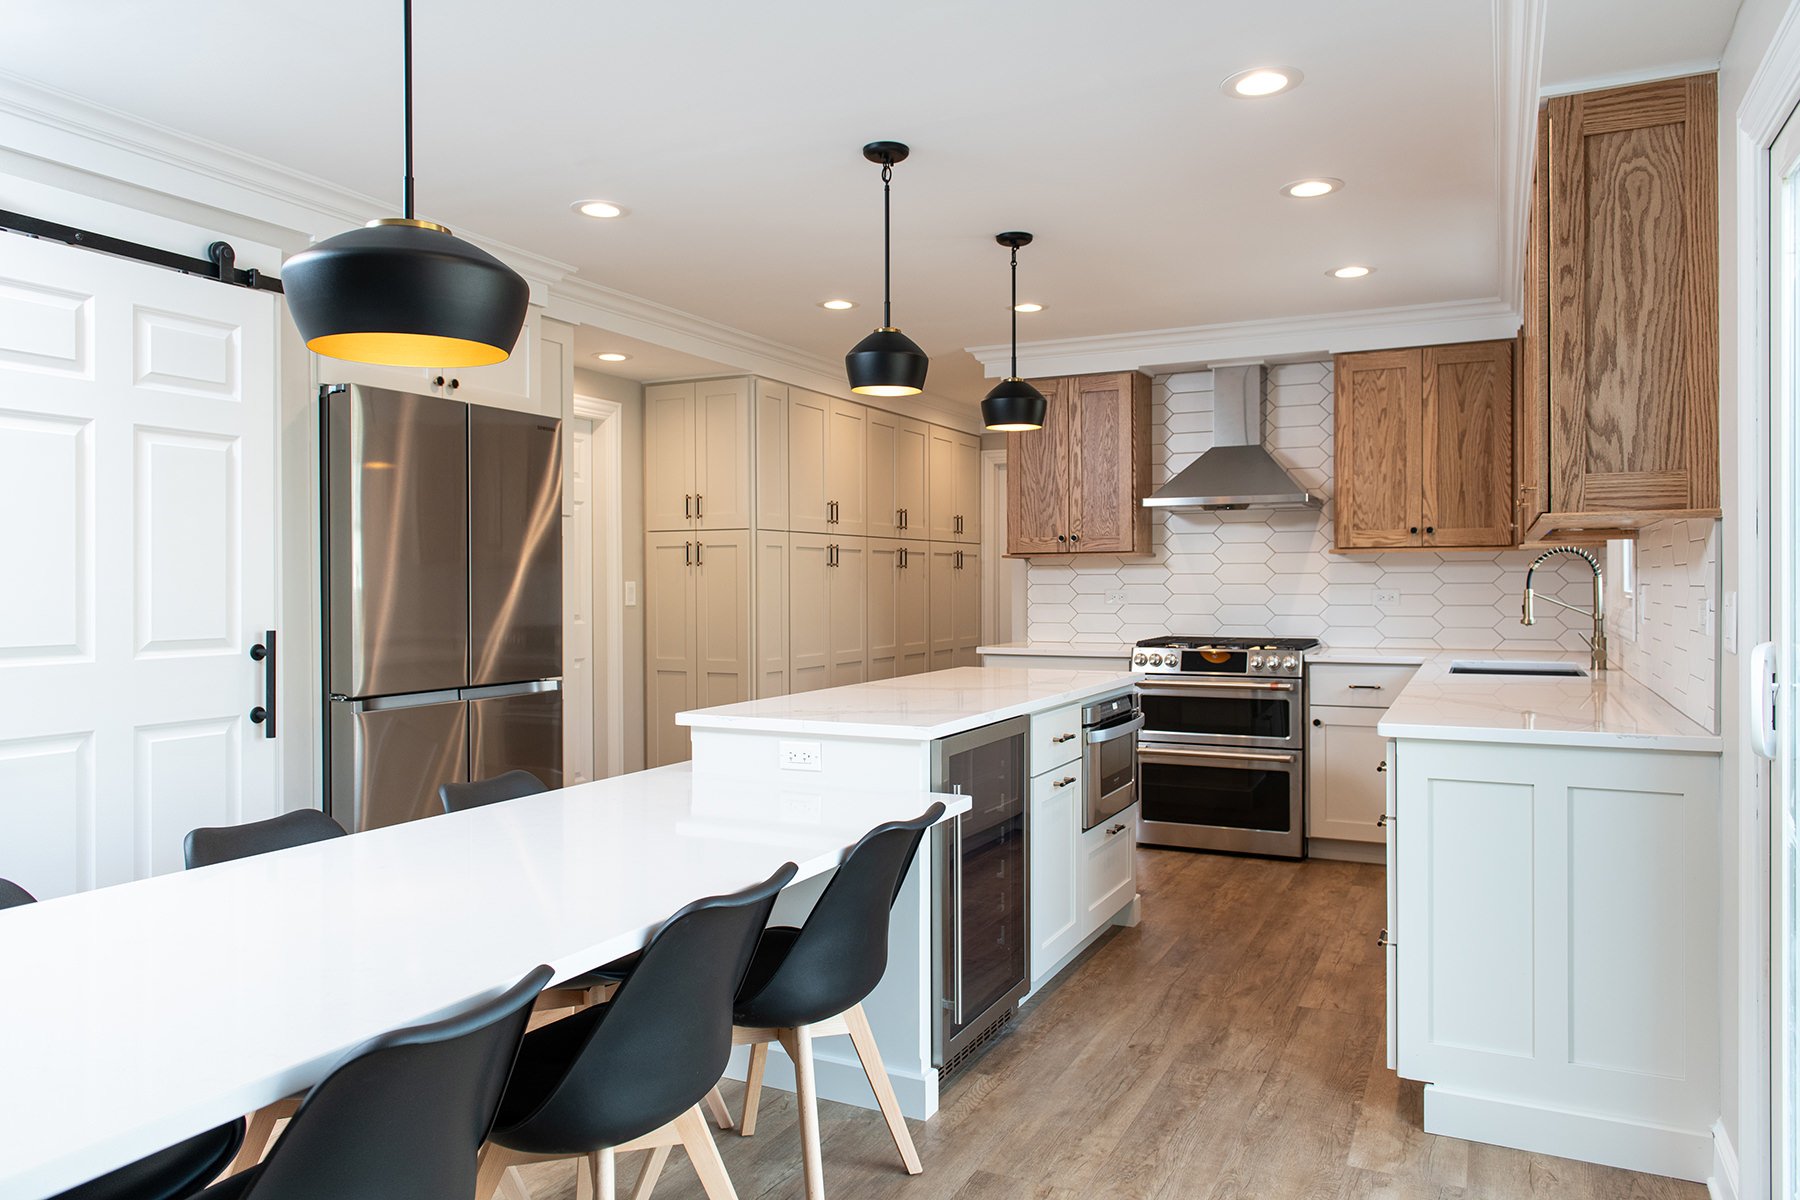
top-left (281, 0), bottom-right (529, 367)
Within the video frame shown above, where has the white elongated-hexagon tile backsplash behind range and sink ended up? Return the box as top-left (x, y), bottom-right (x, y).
top-left (1028, 358), bottom-right (1717, 705)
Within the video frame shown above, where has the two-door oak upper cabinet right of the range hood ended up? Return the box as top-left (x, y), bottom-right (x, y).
top-left (1336, 342), bottom-right (1514, 551)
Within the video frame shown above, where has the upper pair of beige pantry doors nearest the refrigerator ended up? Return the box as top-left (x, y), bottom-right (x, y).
top-left (644, 378), bottom-right (752, 529)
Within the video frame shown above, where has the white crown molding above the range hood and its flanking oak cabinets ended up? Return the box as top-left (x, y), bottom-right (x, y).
top-left (968, 297), bottom-right (1519, 378)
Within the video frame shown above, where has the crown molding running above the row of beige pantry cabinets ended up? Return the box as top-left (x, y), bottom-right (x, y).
top-left (545, 275), bottom-right (981, 432)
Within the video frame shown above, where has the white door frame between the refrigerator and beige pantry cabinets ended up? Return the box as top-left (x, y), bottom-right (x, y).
top-left (574, 394), bottom-right (625, 779)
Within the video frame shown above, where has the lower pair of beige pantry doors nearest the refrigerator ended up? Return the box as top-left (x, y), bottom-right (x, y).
top-left (644, 529), bottom-right (752, 766)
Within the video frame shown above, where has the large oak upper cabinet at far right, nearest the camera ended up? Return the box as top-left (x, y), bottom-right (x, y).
top-left (1521, 76), bottom-right (1719, 542)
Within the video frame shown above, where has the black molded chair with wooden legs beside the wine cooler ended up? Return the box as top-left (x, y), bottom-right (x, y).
top-left (733, 804), bottom-right (943, 1198)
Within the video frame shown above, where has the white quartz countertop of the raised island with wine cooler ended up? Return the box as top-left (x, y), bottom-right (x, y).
top-left (675, 667), bottom-right (1138, 741)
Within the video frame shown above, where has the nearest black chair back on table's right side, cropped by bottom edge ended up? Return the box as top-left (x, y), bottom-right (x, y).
top-left (188, 966), bottom-right (553, 1200)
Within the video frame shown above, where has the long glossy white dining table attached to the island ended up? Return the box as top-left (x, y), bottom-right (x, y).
top-left (0, 765), bottom-right (968, 1200)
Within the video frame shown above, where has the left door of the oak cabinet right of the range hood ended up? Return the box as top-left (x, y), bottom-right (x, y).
top-left (1336, 349), bottom-right (1424, 549)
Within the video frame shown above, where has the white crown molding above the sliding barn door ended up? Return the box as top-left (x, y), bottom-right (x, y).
top-left (0, 72), bottom-right (574, 299)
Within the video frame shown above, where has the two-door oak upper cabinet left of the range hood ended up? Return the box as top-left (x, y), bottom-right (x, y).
top-left (1006, 372), bottom-right (1150, 556)
